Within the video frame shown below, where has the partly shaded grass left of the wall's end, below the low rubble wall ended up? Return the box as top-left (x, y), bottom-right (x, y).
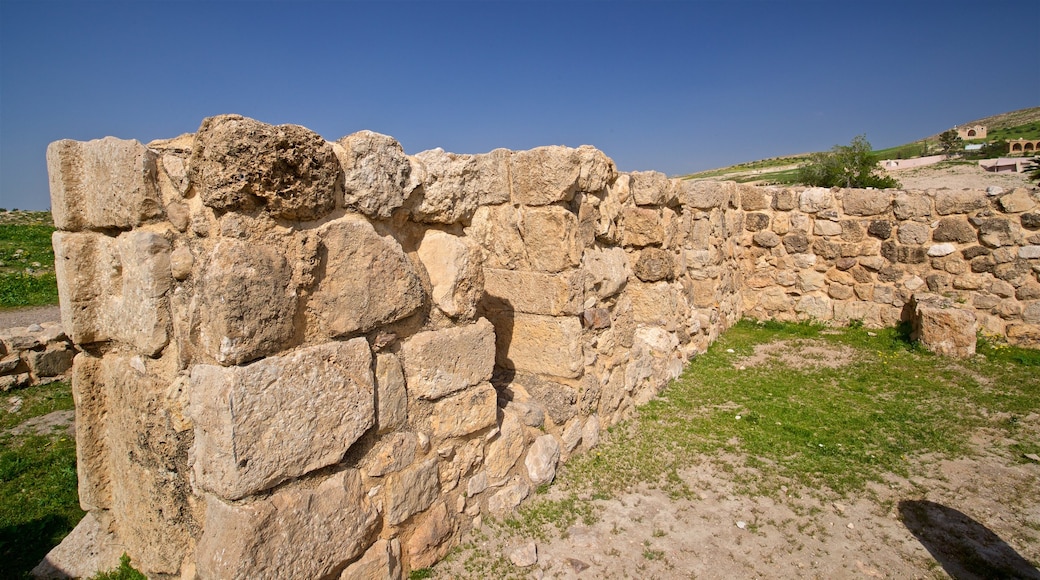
top-left (0, 383), bottom-right (83, 578)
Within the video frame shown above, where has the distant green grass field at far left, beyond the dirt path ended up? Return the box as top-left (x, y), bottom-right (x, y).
top-left (0, 212), bottom-right (58, 308)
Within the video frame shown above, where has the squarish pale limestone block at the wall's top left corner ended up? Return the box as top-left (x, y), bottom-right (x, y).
top-left (47, 137), bottom-right (162, 231)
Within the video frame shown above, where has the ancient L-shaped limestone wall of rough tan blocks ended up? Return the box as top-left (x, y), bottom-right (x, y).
top-left (41, 115), bottom-right (1040, 579)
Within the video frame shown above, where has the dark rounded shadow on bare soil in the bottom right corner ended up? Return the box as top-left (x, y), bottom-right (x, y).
top-left (900, 500), bottom-right (1040, 580)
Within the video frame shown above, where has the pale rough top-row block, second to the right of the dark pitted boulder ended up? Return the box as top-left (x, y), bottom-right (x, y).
top-left (412, 148), bottom-right (511, 223)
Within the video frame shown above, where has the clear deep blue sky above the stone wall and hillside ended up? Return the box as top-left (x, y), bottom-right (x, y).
top-left (0, 0), bottom-right (1040, 209)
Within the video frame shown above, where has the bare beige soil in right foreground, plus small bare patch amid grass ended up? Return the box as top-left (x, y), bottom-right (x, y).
top-left (434, 340), bottom-right (1040, 579)
